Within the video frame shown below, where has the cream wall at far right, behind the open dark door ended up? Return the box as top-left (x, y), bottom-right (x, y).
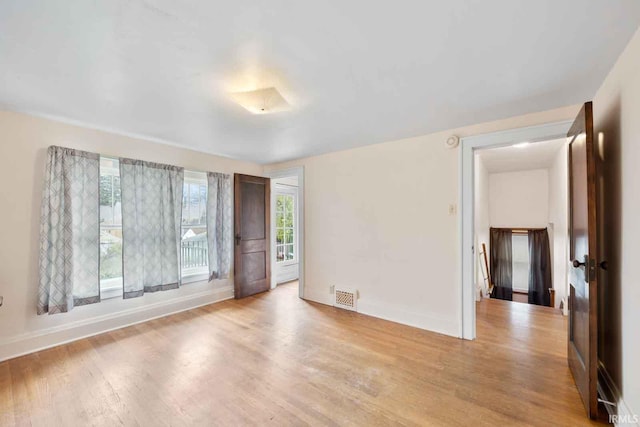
top-left (593, 24), bottom-right (640, 422)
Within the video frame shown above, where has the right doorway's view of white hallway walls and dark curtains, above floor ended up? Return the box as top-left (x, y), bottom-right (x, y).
top-left (473, 138), bottom-right (569, 314)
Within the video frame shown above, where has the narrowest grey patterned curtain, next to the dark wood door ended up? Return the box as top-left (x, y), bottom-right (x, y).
top-left (207, 172), bottom-right (232, 281)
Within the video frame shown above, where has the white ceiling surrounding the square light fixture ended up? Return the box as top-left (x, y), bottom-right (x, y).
top-left (0, 0), bottom-right (640, 163)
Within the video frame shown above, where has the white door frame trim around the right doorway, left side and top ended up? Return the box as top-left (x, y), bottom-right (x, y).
top-left (458, 121), bottom-right (573, 340)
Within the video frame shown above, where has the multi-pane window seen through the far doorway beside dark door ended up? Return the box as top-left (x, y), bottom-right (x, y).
top-left (276, 190), bottom-right (297, 263)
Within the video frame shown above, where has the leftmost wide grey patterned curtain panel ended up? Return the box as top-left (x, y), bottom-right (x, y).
top-left (38, 147), bottom-right (100, 314)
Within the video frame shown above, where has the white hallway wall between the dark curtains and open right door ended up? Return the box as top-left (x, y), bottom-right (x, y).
top-left (548, 147), bottom-right (569, 307)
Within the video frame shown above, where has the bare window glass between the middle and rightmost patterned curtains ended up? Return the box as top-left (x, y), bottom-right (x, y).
top-left (180, 171), bottom-right (209, 282)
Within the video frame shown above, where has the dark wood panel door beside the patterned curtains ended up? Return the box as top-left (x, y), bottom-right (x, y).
top-left (234, 174), bottom-right (271, 299)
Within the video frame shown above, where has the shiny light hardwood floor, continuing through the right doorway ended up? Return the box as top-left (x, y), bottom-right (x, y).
top-left (0, 283), bottom-right (604, 426)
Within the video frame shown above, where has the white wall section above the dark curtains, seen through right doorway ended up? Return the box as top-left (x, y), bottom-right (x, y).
top-left (489, 169), bottom-right (549, 228)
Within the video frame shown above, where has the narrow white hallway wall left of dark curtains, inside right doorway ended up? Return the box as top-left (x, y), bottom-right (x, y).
top-left (473, 154), bottom-right (491, 295)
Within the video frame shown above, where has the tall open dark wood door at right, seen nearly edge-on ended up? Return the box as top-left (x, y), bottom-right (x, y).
top-left (567, 102), bottom-right (598, 418)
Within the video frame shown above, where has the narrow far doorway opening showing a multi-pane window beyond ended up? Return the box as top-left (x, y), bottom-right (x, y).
top-left (267, 167), bottom-right (304, 298)
